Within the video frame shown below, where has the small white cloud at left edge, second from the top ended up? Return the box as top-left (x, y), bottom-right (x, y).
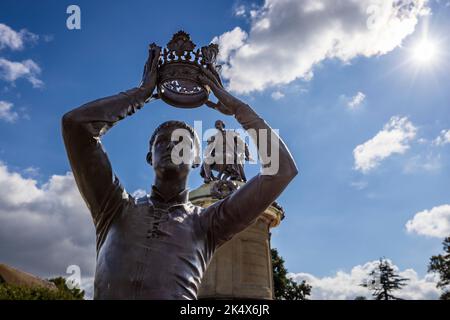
top-left (0, 58), bottom-right (44, 88)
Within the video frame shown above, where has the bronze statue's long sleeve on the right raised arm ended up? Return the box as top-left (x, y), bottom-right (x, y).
top-left (202, 105), bottom-right (298, 247)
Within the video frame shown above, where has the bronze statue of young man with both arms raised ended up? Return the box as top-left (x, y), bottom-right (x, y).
top-left (62, 46), bottom-right (297, 299)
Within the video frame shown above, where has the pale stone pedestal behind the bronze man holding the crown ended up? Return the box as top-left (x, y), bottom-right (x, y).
top-left (189, 182), bottom-right (283, 299)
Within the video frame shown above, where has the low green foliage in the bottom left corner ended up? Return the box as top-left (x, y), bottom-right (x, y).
top-left (0, 277), bottom-right (84, 300)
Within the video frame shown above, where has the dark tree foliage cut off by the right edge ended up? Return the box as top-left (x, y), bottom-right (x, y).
top-left (428, 237), bottom-right (450, 300)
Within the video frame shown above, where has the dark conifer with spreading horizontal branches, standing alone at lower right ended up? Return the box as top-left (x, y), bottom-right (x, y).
top-left (361, 258), bottom-right (409, 300)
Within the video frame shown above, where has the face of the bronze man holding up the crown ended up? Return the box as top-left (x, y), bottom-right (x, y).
top-left (152, 128), bottom-right (195, 178)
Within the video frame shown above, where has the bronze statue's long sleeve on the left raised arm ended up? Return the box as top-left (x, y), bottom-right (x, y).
top-left (62, 88), bottom-right (145, 243)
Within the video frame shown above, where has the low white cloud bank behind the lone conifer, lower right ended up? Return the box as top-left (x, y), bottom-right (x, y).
top-left (291, 261), bottom-right (441, 300)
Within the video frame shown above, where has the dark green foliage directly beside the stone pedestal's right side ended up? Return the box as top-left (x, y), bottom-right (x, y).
top-left (271, 249), bottom-right (311, 300)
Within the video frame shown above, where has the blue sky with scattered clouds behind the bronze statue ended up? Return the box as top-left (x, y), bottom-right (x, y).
top-left (0, 0), bottom-right (450, 297)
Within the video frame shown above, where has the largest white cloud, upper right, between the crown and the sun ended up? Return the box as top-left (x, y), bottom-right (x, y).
top-left (214, 0), bottom-right (428, 93)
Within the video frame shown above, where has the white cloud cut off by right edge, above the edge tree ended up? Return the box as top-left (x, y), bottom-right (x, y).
top-left (406, 204), bottom-right (450, 238)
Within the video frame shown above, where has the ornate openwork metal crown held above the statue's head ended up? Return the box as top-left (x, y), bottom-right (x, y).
top-left (158, 31), bottom-right (221, 108)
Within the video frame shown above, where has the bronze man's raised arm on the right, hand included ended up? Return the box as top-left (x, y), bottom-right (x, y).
top-left (199, 69), bottom-right (298, 245)
